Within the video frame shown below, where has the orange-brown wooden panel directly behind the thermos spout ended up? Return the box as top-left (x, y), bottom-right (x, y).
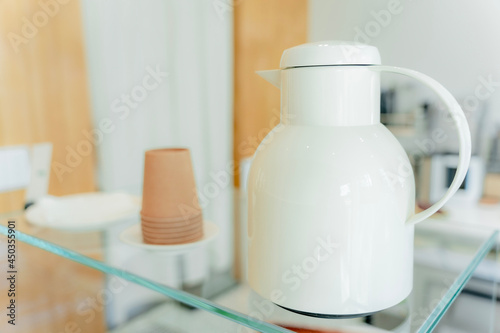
top-left (234, 0), bottom-right (308, 184)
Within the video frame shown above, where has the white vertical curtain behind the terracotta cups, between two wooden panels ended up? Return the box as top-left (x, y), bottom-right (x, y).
top-left (82, 0), bottom-right (233, 320)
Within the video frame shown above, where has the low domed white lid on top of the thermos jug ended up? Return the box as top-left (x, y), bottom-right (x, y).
top-left (280, 40), bottom-right (381, 69)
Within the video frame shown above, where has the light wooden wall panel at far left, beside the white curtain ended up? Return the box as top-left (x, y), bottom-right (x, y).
top-left (0, 0), bottom-right (95, 211)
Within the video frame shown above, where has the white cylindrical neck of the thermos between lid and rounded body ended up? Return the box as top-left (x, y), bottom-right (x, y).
top-left (281, 66), bottom-right (380, 126)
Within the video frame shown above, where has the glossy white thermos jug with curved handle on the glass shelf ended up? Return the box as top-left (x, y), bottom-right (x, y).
top-left (248, 42), bottom-right (471, 315)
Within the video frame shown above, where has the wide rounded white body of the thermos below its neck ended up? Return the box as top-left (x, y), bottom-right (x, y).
top-left (248, 124), bottom-right (415, 314)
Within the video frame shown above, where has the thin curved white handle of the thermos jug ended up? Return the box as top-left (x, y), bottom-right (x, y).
top-left (373, 66), bottom-right (471, 224)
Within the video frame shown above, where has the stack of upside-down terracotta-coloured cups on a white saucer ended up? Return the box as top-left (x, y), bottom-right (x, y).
top-left (141, 148), bottom-right (203, 245)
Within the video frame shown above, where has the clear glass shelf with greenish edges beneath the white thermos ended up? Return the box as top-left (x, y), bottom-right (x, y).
top-left (0, 214), bottom-right (499, 333)
